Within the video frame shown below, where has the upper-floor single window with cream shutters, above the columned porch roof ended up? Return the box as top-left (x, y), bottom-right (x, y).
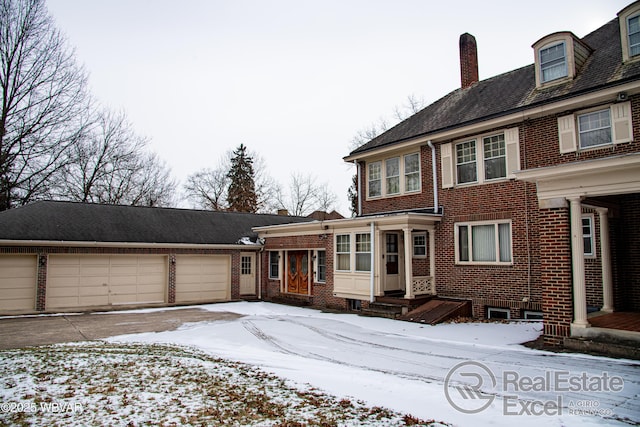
top-left (558, 102), bottom-right (633, 153)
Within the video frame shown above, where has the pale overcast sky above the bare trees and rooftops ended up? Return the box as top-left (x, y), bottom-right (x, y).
top-left (47, 0), bottom-right (631, 216)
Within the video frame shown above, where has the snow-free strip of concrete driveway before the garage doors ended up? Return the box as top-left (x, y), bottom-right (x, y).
top-left (0, 308), bottom-right (241, 350)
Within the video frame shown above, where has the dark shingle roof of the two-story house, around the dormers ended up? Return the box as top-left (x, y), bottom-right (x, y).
top-left (351, 18), bottom-right (640, 155)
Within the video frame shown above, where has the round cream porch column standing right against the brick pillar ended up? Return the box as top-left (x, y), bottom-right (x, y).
top-left (568, 197), bottom-right (589, 328)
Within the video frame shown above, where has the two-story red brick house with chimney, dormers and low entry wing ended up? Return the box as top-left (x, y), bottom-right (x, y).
top-left (255, 2), bottom-right (640, 344)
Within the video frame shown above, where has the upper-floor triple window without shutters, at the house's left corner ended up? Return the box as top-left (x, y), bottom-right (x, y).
top-left (367, 153), bottom-right (421, 199)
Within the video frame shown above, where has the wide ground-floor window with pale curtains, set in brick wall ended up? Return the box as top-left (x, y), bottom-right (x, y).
top-left (455, 220), bottom-right (512, 265)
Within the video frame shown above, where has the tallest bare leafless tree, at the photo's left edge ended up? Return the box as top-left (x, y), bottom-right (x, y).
top-left (0, 0), bottom-right (89, 210)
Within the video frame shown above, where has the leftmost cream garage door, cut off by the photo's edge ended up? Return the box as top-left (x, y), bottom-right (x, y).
top-left (0, 255), bottom-right (38, 311)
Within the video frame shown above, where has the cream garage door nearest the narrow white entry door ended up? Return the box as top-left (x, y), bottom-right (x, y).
top-left (176, 255), bottom-right (231, 302)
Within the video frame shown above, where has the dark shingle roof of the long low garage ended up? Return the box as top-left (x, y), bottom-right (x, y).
top-left (0, 201), bottom-right (311, 244)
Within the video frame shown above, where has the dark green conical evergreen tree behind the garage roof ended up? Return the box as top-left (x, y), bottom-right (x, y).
top-left (227, 144), bottom-right (258, 213)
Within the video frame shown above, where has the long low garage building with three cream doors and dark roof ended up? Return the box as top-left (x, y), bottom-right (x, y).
top-left (0, 201), bottom-right (310, 314)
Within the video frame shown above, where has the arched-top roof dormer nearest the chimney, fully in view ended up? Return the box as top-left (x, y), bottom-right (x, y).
top-left (533, 31), bottom-right (592, 88)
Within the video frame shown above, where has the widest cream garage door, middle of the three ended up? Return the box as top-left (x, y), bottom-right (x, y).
top-left (47, 255), bottom-right (167, 309)
